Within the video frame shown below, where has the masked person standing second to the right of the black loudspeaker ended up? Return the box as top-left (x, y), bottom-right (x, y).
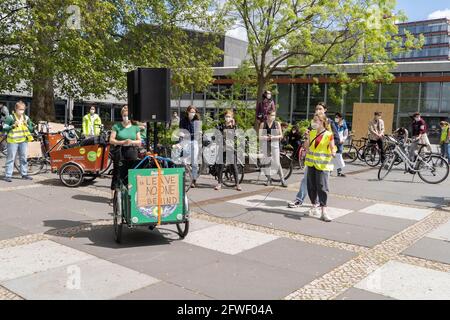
top-left (214, 110), bottom-right (242, 191)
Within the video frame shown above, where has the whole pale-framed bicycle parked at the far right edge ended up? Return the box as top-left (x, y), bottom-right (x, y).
top-left (378, 136), bottom-right (449, 184)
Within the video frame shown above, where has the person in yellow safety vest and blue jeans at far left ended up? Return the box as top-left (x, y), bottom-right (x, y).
top-left (3, 101), bottom-right (34, 182)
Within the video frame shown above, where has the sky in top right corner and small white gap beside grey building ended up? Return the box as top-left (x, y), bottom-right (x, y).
top-left (227, 0), bottom-right (450, 40)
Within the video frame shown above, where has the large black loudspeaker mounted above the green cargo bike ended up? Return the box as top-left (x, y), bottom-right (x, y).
top-left (127, 68), bottom-right (170, 122)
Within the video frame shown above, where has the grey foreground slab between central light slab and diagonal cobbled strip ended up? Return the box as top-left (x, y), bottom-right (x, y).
top-left (239, 239), bottom-right (356, 278)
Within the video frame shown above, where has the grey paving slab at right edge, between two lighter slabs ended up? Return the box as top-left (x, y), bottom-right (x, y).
top-left (403, 237), bottom-right (450, 264)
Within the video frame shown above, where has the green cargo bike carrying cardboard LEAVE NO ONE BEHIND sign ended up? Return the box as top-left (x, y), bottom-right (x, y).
top-left (113, 153), bottom-right (189, 243)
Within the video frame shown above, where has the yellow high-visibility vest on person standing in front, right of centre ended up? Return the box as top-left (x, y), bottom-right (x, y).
top-left (305, 130), bottom-right (333, 171)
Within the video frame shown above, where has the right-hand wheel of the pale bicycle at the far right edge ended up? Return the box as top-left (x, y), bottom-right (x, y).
top-left (418, 154), bottom-right (449, 184)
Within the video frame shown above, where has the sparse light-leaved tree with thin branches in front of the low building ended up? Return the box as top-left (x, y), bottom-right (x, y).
top-left (225, 0), bottom-right (423, 101)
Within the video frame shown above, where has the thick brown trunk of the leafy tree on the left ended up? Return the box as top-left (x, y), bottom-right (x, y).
top-left (31, 66), bottom-right (55, 122)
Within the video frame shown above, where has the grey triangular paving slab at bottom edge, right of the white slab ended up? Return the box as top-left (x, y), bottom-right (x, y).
top-left (116, 281), bottom-right (211, 300)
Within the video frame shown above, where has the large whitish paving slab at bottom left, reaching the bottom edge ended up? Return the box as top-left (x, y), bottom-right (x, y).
top-left (3, 258), bottom-right (159, 300)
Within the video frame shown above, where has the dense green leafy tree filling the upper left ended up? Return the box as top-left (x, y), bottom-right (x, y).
top-left (0, 0), bottom-right (229, 120)
